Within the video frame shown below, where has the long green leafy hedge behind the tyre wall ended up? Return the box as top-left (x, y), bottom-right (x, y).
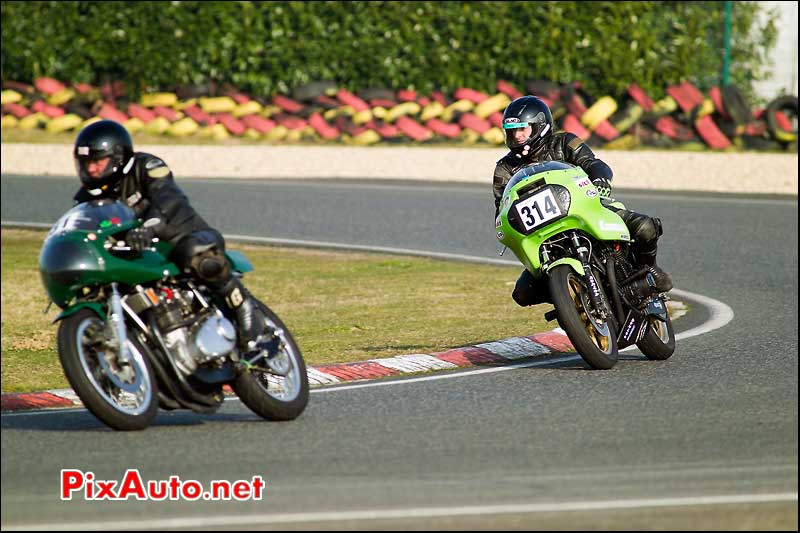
top-left (2, 1), bottom-right (776, 103)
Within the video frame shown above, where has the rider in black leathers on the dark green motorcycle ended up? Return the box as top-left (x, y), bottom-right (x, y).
top-left (73, 120), bottom-right (264, 352)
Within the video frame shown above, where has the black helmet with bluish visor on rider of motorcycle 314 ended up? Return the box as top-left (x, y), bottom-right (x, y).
top-left (503, 96), bottom-right (553, 158)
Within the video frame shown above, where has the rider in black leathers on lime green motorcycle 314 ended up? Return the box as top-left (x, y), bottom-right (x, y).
top-left (493, 96), bottom-right (672, 306)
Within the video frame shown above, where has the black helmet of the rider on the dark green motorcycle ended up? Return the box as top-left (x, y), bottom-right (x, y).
top-left (72, 120), bottom-right (133, 189)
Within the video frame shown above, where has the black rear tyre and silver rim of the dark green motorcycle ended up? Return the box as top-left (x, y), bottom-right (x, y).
top-left (231, 304), bottom-right (309, 421)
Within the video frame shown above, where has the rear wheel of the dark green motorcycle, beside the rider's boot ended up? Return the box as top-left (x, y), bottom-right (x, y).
top-left (231, 301), bottom-right (309, 420)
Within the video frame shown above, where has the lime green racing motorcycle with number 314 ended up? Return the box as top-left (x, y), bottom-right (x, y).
top-left (495, 161), bottom-right (675, 369)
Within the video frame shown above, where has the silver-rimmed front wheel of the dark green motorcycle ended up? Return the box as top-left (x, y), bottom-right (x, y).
top-left (58, 309), bottom-right (158, 430)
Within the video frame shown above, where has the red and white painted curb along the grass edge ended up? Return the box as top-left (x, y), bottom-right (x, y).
top-left (0, 329), bottom-right (575, 413)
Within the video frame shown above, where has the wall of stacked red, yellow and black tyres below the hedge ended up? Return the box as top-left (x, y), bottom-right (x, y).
top-left (2, 77), bottom-right (797, 150)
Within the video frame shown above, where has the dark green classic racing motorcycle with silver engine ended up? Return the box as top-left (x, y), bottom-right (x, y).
top-left (39, 200), bottom-right (309, 430)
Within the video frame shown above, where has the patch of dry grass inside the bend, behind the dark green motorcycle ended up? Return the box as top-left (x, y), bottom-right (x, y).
top-left (0, 229), bottom-right (554, 392)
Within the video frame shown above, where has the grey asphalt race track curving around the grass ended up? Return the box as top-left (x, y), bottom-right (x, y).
top-left (2, 176), bottom-right (798, 529)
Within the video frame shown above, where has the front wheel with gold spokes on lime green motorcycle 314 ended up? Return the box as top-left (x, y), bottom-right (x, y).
top-left (549, 265), bottom-right (618, 369)
